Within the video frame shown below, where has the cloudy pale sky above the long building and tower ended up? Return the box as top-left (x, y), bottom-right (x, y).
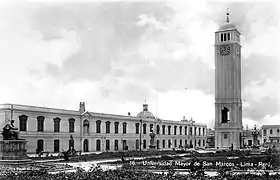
top-left (0, 0), bottom-right (280, 128)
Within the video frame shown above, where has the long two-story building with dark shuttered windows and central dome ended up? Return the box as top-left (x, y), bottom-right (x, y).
top-left (0, 102), bottom-right (207, 153)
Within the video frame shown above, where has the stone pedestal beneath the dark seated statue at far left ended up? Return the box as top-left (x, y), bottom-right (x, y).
top-left (0, 140), bottom-right (32, 164)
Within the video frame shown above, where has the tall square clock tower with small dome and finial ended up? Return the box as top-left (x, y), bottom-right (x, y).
top-left (215, 13), bottom-right (243, 149)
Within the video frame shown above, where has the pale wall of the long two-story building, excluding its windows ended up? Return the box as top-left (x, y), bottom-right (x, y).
top-left (0, 105), bottom-right (207, 153)
